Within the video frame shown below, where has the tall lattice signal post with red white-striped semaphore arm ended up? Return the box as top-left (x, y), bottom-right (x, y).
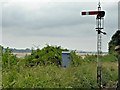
top-left (81, 2), bottom-right (106, 88)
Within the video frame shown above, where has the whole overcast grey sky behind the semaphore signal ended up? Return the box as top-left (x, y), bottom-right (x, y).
top-left (0, 0), bottom-right (118, 51)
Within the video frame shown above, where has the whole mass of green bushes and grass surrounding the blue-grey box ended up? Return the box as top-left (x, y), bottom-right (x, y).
top-left (1, 45), bottom-right (118, 89)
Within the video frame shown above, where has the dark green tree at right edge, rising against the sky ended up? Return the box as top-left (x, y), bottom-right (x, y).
top-left (109, 30), bottom-right (120, 54)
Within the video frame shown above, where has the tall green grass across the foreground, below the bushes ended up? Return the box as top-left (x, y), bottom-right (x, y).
top-left (2, 62), bottom-right (118, 88)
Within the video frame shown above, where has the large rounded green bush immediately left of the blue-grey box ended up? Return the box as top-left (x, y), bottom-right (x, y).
top-left (25, 45), bottom-right (67, 66)
